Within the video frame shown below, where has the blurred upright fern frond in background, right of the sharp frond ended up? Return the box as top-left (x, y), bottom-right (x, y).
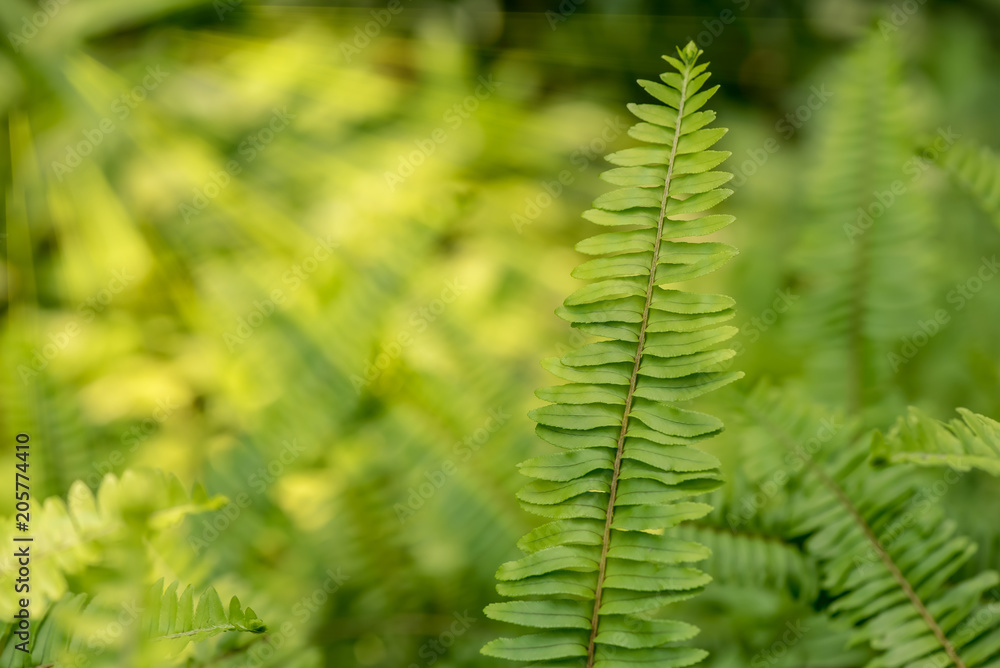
top-left (793, 34), bottom-right (930, 414)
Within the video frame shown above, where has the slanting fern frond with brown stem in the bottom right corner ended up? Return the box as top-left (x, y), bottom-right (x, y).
top-left (748, 384), bottom-right (1000, 668)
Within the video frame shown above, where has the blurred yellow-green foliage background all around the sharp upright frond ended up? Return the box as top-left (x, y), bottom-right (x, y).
top-left (0, 0), bottom-right (1000, 668)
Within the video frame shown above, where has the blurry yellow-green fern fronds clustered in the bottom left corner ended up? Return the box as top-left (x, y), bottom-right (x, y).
top-left (0, 469), bottom-right (264, 668)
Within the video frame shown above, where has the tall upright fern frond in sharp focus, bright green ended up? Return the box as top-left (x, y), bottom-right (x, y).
top-left (483, 43), bottom-right (742, 668)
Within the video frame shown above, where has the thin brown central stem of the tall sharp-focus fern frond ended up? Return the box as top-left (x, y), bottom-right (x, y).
top-left (587, 57), bottom-right (693, 668)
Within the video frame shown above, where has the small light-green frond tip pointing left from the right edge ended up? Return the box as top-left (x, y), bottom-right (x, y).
top-left (871, 408), bottom-right (1000, 476)
